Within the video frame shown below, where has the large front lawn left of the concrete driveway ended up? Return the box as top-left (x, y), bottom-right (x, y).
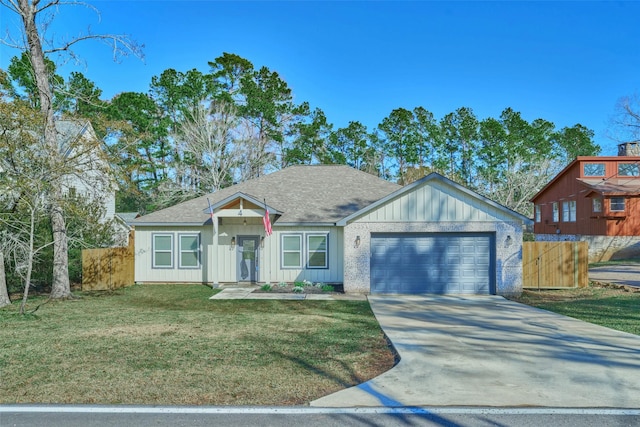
top-left (0, 285), bottom-right (393, 405)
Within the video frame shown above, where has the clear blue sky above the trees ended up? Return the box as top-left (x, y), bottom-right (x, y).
top-left (0, 0), bottom-right (640, 154)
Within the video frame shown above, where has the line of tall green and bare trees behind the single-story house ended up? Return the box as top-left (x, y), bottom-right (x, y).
top-left (5, 53), bottom-right (600, 219)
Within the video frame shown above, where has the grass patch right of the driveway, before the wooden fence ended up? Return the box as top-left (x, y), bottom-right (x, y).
top-left (514, 286), bottom-right (640, 335)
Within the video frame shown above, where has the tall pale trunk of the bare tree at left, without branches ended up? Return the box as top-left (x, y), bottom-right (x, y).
top-left (19, 0), bottom-right (71, 298)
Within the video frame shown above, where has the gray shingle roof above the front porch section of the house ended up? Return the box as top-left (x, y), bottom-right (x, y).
top-left (131, 165), bottom-right (401, 225)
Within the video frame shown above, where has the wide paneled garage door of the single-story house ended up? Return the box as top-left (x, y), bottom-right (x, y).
top-left (371, 233), bottom-right (495, 294)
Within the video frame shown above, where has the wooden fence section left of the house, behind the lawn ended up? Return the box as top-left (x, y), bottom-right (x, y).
top-left (82, 233), bottom-right (134, 291)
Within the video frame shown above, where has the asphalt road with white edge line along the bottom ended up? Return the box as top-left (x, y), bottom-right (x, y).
top-left (0, 406), bottom-right (640, 427)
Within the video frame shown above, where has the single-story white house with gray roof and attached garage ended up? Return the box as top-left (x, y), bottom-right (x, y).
top-left (131, 165), bottom-right (530, 295)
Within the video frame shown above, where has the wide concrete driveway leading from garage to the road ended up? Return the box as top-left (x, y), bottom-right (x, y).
top-left (311, 295), bottom-right (640, 408)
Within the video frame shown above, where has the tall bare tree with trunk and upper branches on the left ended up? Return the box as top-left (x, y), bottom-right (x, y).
top-left (0, 0), bottom-right (141, 298)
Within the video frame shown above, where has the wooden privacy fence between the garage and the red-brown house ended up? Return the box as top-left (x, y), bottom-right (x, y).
top-left (522, 242), bottom-right (589, 289)
